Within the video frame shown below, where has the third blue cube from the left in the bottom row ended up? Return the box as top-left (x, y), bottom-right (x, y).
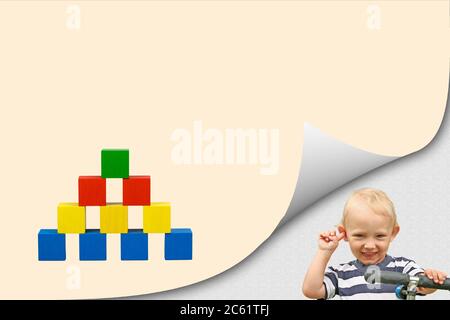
top-left (120, 229), bottom-right (148, 260)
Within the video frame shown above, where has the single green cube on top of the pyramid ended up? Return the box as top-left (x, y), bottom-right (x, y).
top-left (102, 149), bottom-right (130, 178)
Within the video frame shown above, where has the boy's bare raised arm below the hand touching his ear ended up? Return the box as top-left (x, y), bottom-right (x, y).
top-left (303, 249), bottom-right (333, 299)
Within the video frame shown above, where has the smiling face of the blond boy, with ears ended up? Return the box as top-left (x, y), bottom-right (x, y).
top-left (339, 202), bottom-right (400, 265)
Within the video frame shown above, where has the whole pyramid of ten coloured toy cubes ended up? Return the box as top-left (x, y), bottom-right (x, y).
top-left (38, 149), bottom-right (192, 261)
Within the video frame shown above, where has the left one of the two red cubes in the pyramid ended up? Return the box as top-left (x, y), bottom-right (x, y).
top-left (78, 176), bottom-right (106, 206)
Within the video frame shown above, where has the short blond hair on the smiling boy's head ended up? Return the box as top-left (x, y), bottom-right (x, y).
top-left (341, 188), bottom-right (398, 227)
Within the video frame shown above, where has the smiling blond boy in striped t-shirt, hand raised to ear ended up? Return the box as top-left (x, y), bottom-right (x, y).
top-left (303, 188), bottom-right (447, 299)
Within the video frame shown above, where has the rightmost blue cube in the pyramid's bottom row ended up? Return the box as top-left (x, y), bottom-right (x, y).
top-left (164, 228), bottom-right (192, 260)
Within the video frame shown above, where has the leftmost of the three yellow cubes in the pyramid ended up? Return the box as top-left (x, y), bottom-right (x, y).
top-left (58, 203), bottom-right (86, 233)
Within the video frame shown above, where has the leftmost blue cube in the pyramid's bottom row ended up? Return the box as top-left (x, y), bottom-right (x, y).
top-left (38, 229), bottom-right (66, 261)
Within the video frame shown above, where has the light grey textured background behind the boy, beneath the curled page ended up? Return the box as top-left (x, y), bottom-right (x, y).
top-left (138, 82), bottom-right (450, 299)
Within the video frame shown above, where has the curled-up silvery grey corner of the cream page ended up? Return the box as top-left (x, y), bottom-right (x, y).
top-left (278, 122), bottom-right (398, 228)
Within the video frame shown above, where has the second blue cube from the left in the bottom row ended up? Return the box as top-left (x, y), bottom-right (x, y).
top-left (80, 229), bottom-right (106, 261)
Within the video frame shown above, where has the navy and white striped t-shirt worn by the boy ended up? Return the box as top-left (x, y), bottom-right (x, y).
top-left (323, 255), bottom-right (424, 299)
